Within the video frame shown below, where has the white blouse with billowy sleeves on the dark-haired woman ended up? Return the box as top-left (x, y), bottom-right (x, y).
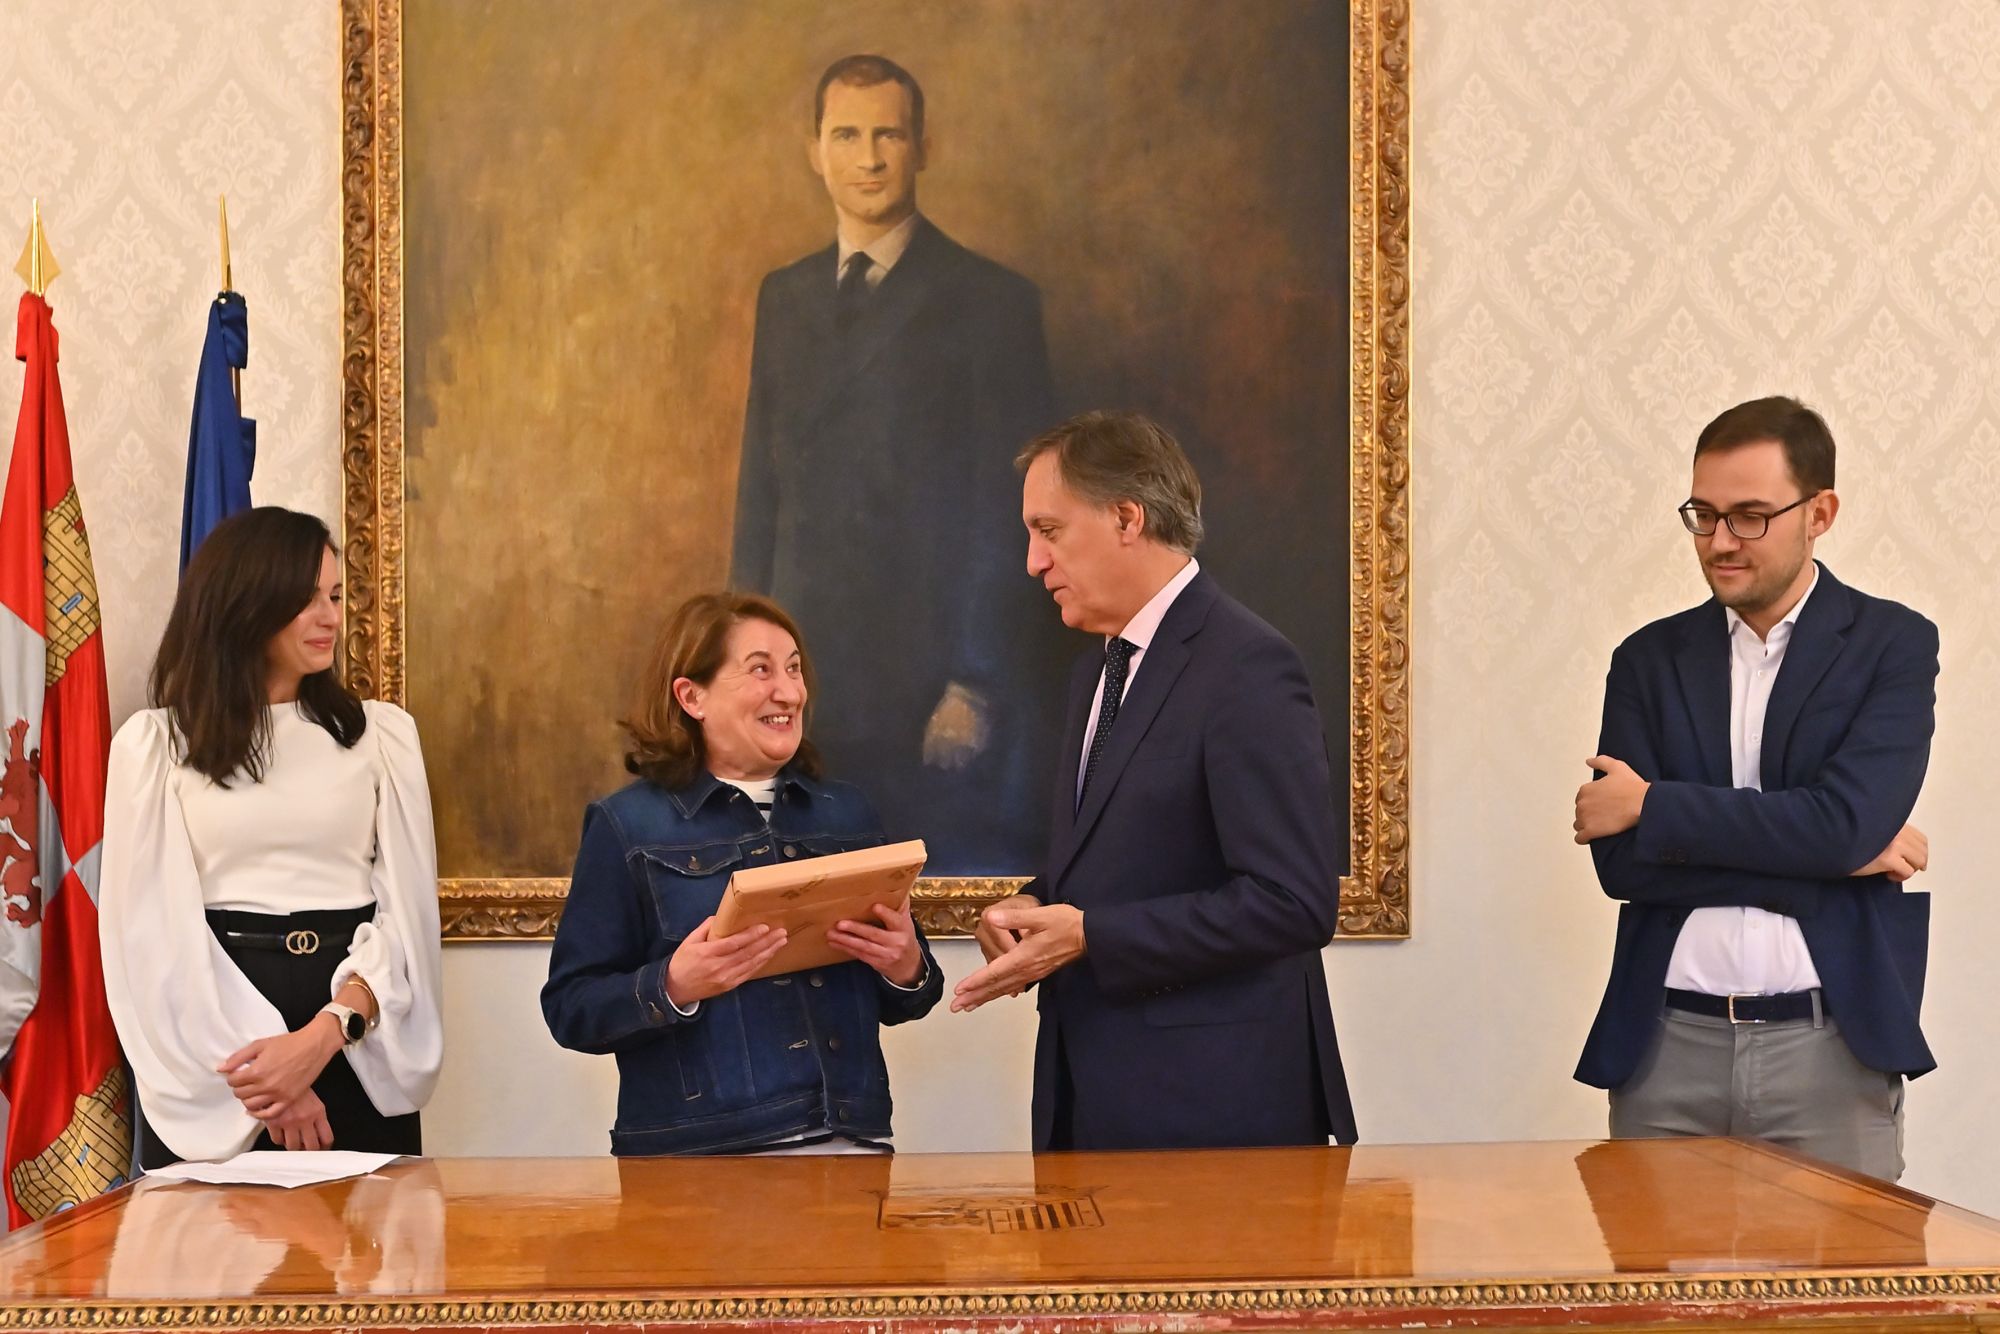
top-left (98, 700), bottom-right (444, 1158)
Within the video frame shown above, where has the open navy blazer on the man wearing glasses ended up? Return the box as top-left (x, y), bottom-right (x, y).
top-left (1576, 566), bottom-right (1938, 1088)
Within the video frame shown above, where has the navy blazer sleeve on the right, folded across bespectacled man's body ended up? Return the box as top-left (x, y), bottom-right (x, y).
top-left (1640, 616), bottom-right (1938, 880)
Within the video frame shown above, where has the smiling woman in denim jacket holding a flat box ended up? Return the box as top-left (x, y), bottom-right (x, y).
top-left (542, 594), bottom-right (944, 1156)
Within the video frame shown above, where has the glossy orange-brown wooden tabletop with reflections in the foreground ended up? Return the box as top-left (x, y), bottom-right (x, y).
top-left (0, 1140), bottom-right (2000, 1304)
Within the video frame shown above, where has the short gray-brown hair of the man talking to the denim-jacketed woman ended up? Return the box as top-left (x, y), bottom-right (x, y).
top-left (1014, 412), bottom-right (1202, 556)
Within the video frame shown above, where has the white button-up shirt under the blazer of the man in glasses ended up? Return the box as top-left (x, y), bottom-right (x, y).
top-left (1666, 566), bottom-right (1820, 996)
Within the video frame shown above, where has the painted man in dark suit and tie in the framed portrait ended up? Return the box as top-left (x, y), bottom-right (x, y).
top-left (730, 56), bottom-right (1052, 874)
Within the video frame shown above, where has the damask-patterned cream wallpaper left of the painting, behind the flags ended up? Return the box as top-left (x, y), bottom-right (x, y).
top-left (0, 0), bottom-right (340, 720)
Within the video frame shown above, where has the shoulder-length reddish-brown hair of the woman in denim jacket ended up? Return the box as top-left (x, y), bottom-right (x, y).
top-left (618, 590), bottom-right (820, 790)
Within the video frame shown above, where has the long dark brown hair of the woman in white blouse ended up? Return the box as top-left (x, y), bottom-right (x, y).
top-left (148, 506), bottom-right (368, 786)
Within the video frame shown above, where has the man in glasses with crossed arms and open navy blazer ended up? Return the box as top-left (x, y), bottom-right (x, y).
top-left (1574, 398), bottom-right (1938, 1180)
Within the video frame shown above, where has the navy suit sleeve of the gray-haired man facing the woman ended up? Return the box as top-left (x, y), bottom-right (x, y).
top-left (1084, 638), bottom-right (1340, 998)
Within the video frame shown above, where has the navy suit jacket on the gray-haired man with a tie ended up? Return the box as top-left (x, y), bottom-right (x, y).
top-left (1028, 574), bottom-right (1354, 1150)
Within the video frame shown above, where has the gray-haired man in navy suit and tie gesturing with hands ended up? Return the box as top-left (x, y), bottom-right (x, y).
top-left (952, 412), bottom-right (1354, 1150)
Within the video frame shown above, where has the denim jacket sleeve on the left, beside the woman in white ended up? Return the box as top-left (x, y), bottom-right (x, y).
top-left (542, 806), bottom-right (706, 1054)
